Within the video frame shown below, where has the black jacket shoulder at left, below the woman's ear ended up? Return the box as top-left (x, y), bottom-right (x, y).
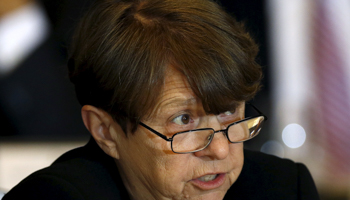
top-left (4, 140), bottom-right (127, 200)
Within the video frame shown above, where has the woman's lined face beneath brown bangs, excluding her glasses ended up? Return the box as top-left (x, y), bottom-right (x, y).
top-left (112, 68), bottom-right (244, 200)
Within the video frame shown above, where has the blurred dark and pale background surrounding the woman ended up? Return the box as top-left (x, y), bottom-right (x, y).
top-left (0, 0), bottom-right (350, 200)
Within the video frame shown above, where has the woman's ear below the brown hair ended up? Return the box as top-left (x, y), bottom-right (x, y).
top-left (81, 105), bottom-right (119, 159)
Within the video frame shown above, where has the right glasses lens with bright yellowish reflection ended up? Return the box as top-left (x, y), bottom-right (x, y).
top-left (227, 116), bottom-right (264, 142)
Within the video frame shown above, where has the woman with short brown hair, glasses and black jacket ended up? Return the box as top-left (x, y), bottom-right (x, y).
top-left (4, 0), bottom-right (318, 200)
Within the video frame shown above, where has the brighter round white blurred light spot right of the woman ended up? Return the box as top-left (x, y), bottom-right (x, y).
top-left (282, 124), bottom-right (306, 148)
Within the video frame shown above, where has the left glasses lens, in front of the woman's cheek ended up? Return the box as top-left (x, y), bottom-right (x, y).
top-left (171, 129), bottom-right (214, 153)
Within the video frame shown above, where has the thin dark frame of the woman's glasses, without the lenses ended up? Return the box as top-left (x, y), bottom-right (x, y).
top-left (139, 103), bottom-right (267, 154)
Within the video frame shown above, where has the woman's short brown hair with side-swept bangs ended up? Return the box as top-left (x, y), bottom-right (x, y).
top-left (68, 0), bottom-right (262, 132)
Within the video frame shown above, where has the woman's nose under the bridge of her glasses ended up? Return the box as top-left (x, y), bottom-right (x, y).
top-left (194, 117), bottom-right (230, 160)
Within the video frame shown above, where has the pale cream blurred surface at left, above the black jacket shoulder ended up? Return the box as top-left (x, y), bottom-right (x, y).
top-left (0, 141), bottom-right (86, 191)
